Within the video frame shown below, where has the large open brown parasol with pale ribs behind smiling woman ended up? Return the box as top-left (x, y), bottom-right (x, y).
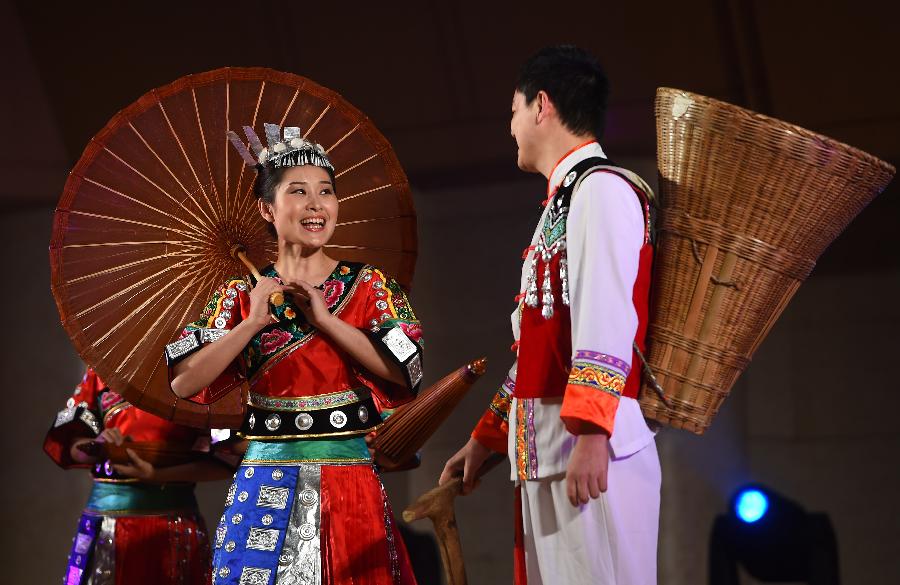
top-left (50, 68), bottom-right (416, 427)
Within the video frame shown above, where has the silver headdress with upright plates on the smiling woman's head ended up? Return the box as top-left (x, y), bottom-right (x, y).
top-left (228, 124), bottom-right (334, 171)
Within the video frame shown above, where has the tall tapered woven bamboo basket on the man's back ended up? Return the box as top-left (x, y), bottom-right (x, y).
top-left (640, 88), bottom-right (895, 434)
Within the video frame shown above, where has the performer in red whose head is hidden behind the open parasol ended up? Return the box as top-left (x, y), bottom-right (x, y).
top-left (44, 368), bottom-right (234, 585)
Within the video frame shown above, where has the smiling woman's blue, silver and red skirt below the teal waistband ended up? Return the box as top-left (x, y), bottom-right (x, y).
top-left (213, 459), bottom-right (416, 585)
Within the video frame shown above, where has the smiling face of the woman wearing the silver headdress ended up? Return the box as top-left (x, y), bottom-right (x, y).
top-left (260, 165), bottom-right (338, 249)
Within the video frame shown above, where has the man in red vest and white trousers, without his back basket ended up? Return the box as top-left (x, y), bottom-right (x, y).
top-left (441, 46), bottom-right (660, 585)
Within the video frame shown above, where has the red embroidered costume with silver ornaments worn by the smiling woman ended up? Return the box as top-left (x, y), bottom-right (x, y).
top-left (166, 262), bottom-right (424, 585)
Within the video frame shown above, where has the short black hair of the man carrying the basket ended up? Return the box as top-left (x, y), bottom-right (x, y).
top-left (516, 45), bottom-right (609, 138)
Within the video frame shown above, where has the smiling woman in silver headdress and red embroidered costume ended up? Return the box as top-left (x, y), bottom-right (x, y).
top-left (166, 124), bottom-right (423, 585)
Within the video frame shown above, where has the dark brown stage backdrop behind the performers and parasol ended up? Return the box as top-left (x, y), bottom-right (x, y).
top-left (0, 0), bottom-right (900, 585)
